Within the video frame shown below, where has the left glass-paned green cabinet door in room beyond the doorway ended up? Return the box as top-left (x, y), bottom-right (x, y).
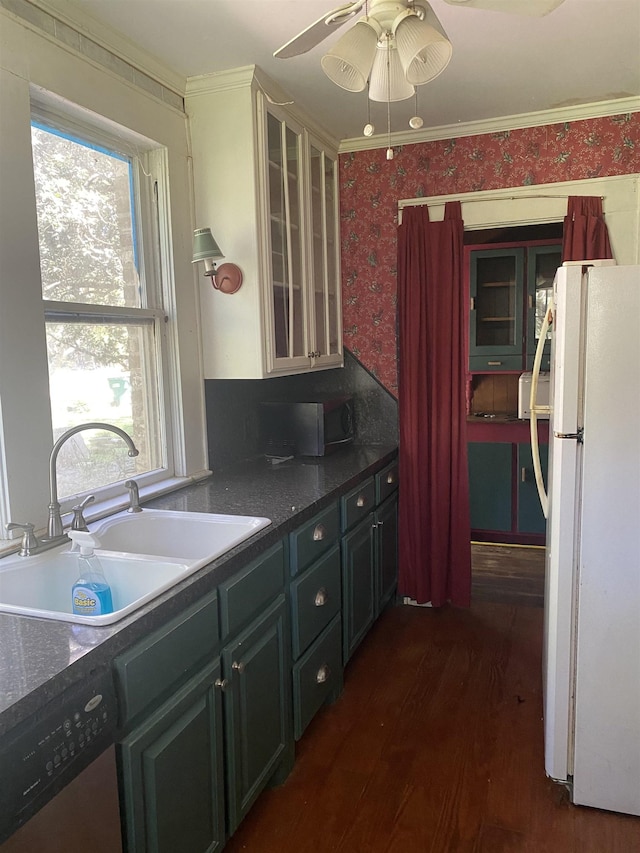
top-left (469, 248), bottom-right (524, 370)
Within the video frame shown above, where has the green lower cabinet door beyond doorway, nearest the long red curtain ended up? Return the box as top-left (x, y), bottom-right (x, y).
top-left (467, 441), bottom-right (512, 532)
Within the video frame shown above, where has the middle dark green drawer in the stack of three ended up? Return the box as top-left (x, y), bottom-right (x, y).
top-left (291, 543), bottom-right (342, 659)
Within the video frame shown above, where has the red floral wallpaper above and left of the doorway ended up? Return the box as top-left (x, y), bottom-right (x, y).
top-left (340, 113), bottom-right (640, 396)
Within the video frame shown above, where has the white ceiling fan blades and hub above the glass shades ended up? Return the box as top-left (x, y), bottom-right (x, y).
top-left (273, 0), bottom-right (564, 59)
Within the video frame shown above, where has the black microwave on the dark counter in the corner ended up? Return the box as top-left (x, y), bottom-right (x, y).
top-left (260, 397), bottom-right (354, 456)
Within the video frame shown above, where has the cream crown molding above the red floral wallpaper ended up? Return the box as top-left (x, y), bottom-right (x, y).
top-left (338, 96), bottom-right (640, 154)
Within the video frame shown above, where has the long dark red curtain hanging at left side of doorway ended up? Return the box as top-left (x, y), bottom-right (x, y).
top-left (398, 202), bottom-right (471, 606)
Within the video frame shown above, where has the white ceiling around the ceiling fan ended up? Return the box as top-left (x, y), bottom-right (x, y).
top-left (48, 0), bottom-right (640, 139)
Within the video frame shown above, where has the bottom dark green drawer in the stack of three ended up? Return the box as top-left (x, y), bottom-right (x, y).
top-left (293, 616), bottom-right (343, 740)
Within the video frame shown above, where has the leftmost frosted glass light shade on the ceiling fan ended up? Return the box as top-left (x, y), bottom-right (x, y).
top-left (320, 17), bottom-right (382, 92)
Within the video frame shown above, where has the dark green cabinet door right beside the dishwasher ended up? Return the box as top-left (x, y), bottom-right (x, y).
top-left (117, 661), bottom-right (225, 853)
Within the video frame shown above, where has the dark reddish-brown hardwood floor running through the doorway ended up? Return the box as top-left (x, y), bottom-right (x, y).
top-left (226, 546), bottom-right (640, 853)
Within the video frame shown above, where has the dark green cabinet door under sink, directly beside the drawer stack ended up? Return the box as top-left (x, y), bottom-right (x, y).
top-left (222, 595), bottom-right (293, 834)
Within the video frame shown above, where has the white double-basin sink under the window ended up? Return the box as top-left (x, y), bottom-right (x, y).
top-left (0, 509), bottom-right (271, 625)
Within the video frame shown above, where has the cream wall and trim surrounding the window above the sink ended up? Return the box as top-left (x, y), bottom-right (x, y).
top-left (0, 9), bottom-right (207, 537)
